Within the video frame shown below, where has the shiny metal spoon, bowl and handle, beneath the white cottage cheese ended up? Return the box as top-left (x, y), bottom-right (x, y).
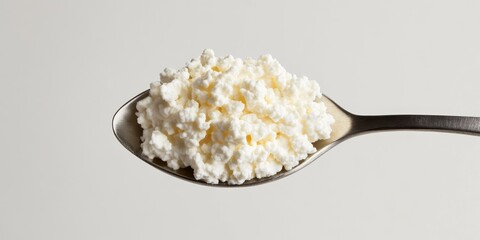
top-left (112, 90), bottom-right (480, 187)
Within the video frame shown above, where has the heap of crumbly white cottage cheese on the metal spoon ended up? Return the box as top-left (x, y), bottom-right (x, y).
top-left (137, 49), bottom-right (334, 184)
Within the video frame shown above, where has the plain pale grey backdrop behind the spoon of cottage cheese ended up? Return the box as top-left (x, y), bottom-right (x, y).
top-left (0, 0), bottom-right (480, 240)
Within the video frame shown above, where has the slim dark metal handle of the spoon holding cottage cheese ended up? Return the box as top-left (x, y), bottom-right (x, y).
top-left (354, 115), bottom-right (480, 136)
